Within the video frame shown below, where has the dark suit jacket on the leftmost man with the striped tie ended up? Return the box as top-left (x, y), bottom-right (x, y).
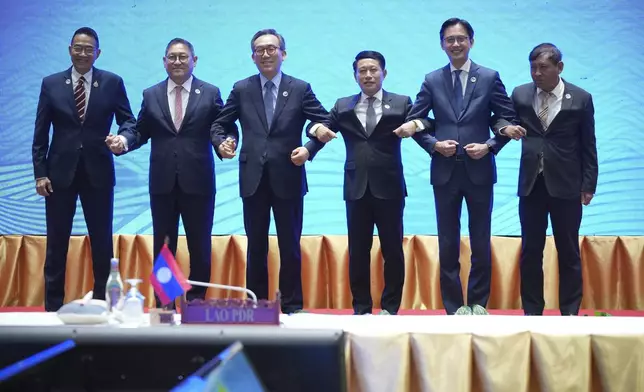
top-left (32, 67), bottom-right (135, 190)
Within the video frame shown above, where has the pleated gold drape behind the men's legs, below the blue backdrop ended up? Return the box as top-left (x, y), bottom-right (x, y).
top-left (0, 235), bottom-right (644, 310)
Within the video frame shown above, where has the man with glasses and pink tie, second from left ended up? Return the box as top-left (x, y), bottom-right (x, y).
top-left (107, 38), bottom-right (236, 299)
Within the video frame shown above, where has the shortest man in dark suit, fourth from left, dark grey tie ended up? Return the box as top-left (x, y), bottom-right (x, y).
top-left (310, 51), bottom-right (430, 315)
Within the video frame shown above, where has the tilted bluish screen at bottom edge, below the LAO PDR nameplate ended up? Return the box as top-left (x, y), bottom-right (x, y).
top-left (172, 342), bottom-right (266, 392)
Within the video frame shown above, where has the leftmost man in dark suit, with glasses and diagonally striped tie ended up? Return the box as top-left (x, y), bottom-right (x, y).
top-left (32, 27), bottom-right (134, 311)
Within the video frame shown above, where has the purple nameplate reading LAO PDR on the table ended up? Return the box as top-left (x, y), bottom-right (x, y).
top-left (181, 298), bottom-right (280, 325)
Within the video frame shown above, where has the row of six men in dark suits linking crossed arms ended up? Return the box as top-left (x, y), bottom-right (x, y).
top-left (33, 18), bottom-right (597, 315)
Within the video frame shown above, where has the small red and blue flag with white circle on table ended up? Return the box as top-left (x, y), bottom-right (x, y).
top-left (150, 244), bottom-right (192, 305)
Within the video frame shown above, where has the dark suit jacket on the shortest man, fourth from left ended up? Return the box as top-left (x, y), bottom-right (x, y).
top-left (309, 90), bottom-right (430, 200)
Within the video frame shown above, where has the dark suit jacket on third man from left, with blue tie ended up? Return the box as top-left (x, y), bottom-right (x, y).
top-left (212, 74), bottom-right (328, 199)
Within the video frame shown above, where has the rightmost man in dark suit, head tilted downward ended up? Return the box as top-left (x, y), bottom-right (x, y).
top-left (501, 43), bottom-right (598, 315)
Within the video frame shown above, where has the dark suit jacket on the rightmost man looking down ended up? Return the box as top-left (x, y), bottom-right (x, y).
top-left (512, 81), bottom-right (598, 199)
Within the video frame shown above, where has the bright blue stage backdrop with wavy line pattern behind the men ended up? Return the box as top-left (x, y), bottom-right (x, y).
top-left (0, 0), bottom-right (644, 235)
